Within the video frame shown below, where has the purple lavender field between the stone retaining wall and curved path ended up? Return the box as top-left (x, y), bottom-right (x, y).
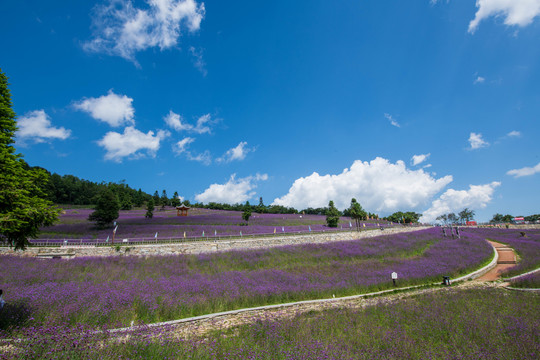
top-left (0, 228), bottom-right (493, 334)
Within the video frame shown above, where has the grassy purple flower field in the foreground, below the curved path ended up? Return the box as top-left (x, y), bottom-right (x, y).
top-left (0, 288), bottom-right (540, 360)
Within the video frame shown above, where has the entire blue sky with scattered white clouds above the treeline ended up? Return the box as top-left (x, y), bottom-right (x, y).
top-left (0, 0), bottom-right (540, 221)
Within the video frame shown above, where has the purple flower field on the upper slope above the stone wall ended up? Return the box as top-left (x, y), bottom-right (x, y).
top-left (33, 208), bottom-right (393, 240)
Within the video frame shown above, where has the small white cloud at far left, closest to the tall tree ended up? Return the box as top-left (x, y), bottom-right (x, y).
top-left (17, 110), bottom-right (71, 142)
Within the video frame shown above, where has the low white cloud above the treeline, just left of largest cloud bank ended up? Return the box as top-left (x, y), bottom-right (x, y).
top-left (195, 174), bottom-right (268, 204)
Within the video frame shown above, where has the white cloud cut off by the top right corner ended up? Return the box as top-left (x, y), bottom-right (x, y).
top-left (469, 0), bottom-right (540, 34)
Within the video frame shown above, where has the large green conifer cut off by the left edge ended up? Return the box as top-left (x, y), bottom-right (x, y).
top-left (0, 69), bottom-right (60, 249)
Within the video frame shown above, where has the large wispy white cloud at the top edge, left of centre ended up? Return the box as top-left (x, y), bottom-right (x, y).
top-left (83, 0), bottom-right (205, 64)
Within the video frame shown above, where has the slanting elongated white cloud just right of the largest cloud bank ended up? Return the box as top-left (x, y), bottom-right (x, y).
top-left (420, 181), bottom-right (501, 223)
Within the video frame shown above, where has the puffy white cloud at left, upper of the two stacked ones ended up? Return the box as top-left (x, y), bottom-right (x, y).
top-left (73, 90), bottom-right (135, 127)
